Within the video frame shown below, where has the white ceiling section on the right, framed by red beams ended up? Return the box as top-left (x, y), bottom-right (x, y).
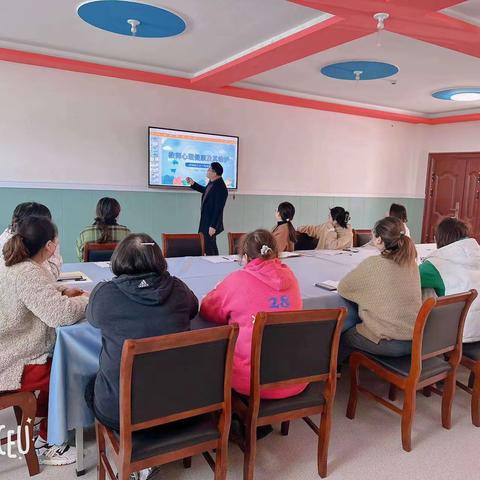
top-left (242, 31), bottom-right (480, 114)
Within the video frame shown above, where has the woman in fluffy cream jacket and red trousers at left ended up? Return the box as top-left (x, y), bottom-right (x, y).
top-left (0, 216), bottom-right (88, 465)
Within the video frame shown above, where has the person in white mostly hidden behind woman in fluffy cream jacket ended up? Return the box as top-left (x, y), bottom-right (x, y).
top-left (0, 202), bottom-right (63, 280)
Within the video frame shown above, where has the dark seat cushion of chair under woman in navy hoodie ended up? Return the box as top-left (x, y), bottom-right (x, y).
top-left (114, 414), bottom-right (220, 462)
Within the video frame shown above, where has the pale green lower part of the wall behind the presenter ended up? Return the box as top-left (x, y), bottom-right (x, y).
top-left (0, 187), bottom-right (423, 262)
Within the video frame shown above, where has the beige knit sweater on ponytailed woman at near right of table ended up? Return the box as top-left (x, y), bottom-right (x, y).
top-left (338, 255), bottom-right (422, 343)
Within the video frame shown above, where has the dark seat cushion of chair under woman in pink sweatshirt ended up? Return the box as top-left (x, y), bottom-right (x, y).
top-left (235, 382), bottom-right (325, 417)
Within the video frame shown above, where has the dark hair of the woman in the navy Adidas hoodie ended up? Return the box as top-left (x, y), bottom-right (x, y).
top-left (111, 233), bottom-right (167, 277)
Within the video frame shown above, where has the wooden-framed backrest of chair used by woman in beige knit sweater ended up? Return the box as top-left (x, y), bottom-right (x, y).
top-left (410, 290), bottom-right (477, 375)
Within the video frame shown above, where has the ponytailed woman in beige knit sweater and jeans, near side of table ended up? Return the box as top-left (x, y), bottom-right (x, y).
top-left (338, 217), bottom-right (422, 359)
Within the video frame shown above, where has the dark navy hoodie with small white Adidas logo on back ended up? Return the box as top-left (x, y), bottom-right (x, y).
top-left (87, 272), bottom-right (198, 430)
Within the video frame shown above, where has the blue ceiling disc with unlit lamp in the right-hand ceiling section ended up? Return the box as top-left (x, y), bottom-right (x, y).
top-left (321, 60), bottom-right (398, 80)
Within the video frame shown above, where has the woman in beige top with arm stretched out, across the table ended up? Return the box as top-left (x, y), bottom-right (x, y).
top-left (298, 207), bottom-right (353, 250)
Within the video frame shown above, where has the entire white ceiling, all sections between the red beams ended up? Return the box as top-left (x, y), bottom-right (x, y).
top-left (0, 0), bottom-right (480, 116)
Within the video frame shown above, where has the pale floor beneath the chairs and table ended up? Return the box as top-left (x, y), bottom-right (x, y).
top-left (0, 368), bottom-right (480, 480)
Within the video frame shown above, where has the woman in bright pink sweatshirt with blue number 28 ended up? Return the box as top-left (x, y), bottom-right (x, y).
top-left (200, 230), bottom-right (306, 399)
